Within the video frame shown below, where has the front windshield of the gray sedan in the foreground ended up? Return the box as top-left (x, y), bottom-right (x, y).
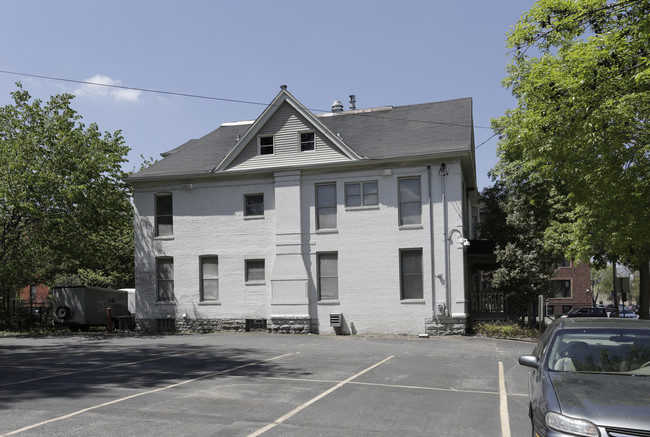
top-left (546, 329), bottom-right (650, 376)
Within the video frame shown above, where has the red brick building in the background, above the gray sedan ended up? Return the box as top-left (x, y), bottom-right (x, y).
top-left (547, 261), bottom-right (593, 316)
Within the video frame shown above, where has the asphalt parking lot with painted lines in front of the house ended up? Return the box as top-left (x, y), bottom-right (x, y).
top-left (0, 333), bottom-right (534, 437)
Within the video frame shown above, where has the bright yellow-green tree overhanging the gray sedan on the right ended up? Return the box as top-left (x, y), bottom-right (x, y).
top-left (493, 0), bottom-right (650, 319)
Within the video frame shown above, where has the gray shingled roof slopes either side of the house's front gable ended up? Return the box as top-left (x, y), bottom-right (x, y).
top-left (130, 98), bottom-right (473, 180)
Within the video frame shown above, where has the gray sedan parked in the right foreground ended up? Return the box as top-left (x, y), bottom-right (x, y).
top-left (519, 317), bottom-right (650, 437)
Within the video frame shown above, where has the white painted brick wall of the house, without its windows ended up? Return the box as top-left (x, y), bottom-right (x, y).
top-left (134, 161), bottom-right (466, 334)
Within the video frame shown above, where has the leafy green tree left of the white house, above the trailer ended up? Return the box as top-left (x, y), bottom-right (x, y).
top-left (0, 84), bottom-right (133, 302)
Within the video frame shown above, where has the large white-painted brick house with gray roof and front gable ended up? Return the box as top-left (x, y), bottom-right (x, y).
top-left (129, 86), bottom-right (476, 334)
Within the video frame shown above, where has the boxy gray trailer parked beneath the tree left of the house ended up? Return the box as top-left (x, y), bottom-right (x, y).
top-left (51, 285), bottom-right (131, 331)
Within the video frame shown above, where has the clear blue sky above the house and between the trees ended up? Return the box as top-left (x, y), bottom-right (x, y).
top-left (0, 0), bottom-right (534, 189)
